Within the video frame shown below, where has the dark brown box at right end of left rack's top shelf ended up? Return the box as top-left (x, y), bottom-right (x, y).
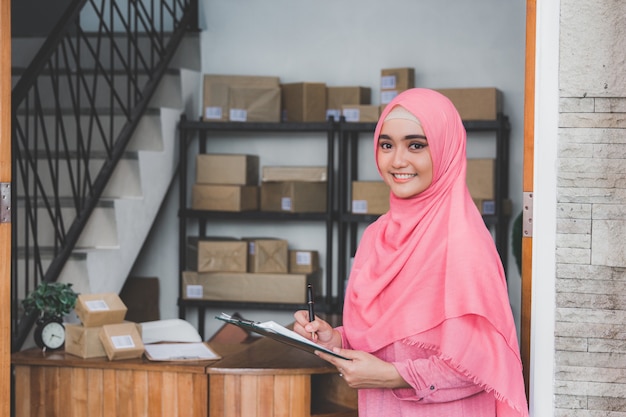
top-left (281, 82), bottom-right (326, 122)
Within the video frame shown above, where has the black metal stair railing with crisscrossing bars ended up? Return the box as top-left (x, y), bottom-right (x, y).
top-left (11, 0), bottom-right (198, 351)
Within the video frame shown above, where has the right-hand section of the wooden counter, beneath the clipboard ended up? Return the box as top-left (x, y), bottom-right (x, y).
top-left (207, 338), bottom-right (357, 417)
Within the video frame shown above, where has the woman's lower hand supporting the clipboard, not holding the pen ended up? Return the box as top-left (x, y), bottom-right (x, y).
top-left (315, 348), bottom-right (410, 389)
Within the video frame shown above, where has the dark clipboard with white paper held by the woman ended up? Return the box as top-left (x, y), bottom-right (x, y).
top-left (215, 313), bottom-right (351, 361)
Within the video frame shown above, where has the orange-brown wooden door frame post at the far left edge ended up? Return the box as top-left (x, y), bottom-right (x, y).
top-left (0, 0), bottom-right (11, 416)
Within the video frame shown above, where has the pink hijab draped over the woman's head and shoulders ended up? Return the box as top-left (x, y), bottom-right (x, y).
top-left (343, 88), bottom-right (528, 416)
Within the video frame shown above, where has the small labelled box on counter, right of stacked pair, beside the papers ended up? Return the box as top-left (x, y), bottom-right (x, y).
top-left (99, 322), bottom-right (145, 361)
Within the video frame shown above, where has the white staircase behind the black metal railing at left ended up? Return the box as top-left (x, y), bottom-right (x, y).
top-left (12, 0), bottom-right (201, 350)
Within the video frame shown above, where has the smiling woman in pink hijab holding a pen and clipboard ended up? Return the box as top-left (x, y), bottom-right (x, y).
top-left (294, 88), bottom-right (528, 417)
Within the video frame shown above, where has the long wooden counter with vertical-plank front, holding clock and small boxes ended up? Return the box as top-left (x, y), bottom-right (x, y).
top-left (12, 338), bottom-right (357, 417)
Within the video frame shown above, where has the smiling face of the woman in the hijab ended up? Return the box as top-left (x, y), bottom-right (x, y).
top-left (376, 114), bottom-right (433, 198)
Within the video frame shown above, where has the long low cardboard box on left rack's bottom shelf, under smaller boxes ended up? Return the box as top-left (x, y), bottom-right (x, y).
top-left (182, 270), bottom-right (322, 304)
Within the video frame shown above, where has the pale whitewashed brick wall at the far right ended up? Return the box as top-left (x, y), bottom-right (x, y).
top-left (552, 0), bottom-right (626, 417)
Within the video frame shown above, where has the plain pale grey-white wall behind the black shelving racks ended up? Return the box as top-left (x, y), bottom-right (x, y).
top-left (134, 0), bottom-right (526, 334)
